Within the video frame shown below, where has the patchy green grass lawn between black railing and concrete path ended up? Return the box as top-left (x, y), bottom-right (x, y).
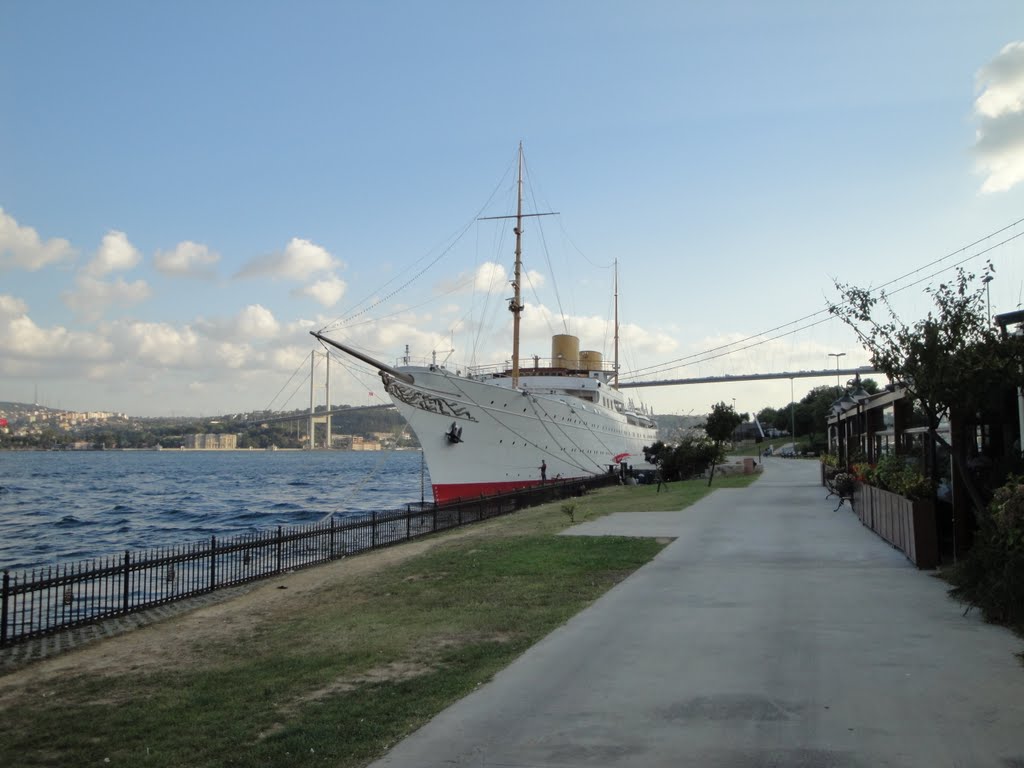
top-left (0, 477), bottom-right (754, 766)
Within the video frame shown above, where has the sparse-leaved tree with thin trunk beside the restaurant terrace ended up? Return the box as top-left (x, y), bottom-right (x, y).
top-left (828, 263), bottom-right (1022, 513)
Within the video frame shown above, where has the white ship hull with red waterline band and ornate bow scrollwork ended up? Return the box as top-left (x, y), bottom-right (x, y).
top-left (381, 367), bottom-right (656, 504)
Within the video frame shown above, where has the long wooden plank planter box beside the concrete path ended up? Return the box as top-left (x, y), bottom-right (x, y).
top-left (853, 483), bottom-right (939, 568)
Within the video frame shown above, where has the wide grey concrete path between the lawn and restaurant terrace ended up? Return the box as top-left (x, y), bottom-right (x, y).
top-left (374, 459), bottom-right (1024, 768)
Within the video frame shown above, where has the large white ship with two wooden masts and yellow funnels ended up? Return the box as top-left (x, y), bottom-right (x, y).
top-left (311, 146), bottom-right (657, 504)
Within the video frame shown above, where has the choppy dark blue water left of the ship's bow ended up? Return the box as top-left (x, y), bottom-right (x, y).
top-left (0, 451), bottom-right (432, 570)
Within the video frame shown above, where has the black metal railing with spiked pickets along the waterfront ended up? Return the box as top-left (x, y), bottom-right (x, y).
top-left (0, 474), bottom-right (618, 646)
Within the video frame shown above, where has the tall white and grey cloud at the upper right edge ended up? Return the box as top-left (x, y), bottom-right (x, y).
top-left (974, 42), bottom-right (1024, 193)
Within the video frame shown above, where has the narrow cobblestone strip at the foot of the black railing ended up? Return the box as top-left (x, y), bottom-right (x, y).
top-left (0, 582), bottom-right (260, 674)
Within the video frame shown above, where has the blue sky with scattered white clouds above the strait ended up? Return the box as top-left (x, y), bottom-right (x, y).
top-left (0, 0), bottom-right (1024, 417)
